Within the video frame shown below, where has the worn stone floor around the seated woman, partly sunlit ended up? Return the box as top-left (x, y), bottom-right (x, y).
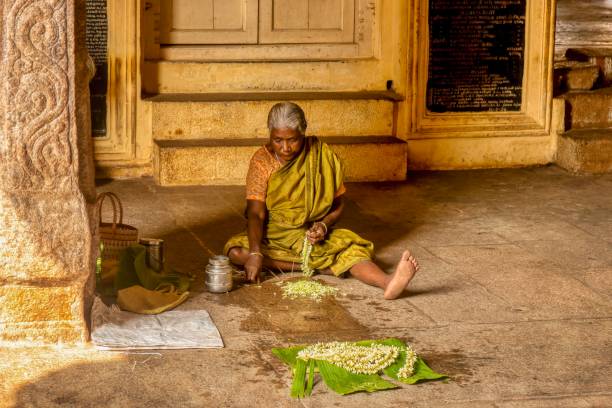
top-left (0, 167), bottom-right (612, 408)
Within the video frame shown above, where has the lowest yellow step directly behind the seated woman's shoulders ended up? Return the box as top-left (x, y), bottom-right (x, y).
top-left (154, 136), bottom-right (407, 186)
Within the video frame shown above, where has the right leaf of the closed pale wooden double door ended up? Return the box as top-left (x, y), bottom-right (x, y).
top-left (259, 0), bottom-right (355, 44)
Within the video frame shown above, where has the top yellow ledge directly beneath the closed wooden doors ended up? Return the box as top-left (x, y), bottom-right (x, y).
top-left (141, 60), bottom-right (394, 93)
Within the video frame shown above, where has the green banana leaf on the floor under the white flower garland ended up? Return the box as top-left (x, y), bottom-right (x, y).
top-left (272, 338), bottom-right (447, 398)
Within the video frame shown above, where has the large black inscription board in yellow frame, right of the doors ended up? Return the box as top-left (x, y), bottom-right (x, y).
top-left (427, 0), bottom-right (526, 112)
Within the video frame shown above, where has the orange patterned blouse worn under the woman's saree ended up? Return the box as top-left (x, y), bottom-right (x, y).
top-left (246, 146), bottom-right (346, 202)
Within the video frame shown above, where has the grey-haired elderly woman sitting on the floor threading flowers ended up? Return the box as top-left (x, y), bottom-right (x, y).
top-left (225, 102), bottom-right (419, 299)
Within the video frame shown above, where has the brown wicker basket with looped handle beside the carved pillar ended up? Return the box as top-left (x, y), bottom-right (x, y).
top-left (96, 192), bottom-right (138, 260)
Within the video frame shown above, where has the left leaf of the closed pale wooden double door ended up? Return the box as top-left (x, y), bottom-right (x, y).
top-left (160, 0), bottom-right (258, 45)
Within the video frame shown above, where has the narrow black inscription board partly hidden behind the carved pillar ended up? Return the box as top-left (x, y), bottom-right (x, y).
top-left (86, 0), bottom-right (108, 137)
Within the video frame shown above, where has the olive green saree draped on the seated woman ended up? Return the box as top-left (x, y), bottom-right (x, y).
top-left (224, 137), bottom-right (374, 275)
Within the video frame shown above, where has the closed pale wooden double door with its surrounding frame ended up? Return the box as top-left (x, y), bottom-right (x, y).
top-left (151, 0), bottom-right (376, 61)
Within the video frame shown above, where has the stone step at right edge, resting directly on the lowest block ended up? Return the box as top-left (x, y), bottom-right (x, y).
top-left (562, 88), bottom-right (612, 129)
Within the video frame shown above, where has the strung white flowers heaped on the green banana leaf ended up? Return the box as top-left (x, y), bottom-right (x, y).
top-left (298, 341), bottom-right (417, 378)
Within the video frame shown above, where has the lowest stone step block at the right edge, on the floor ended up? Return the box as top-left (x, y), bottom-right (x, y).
top-left (556, 128), bottom-right (612, 173)
